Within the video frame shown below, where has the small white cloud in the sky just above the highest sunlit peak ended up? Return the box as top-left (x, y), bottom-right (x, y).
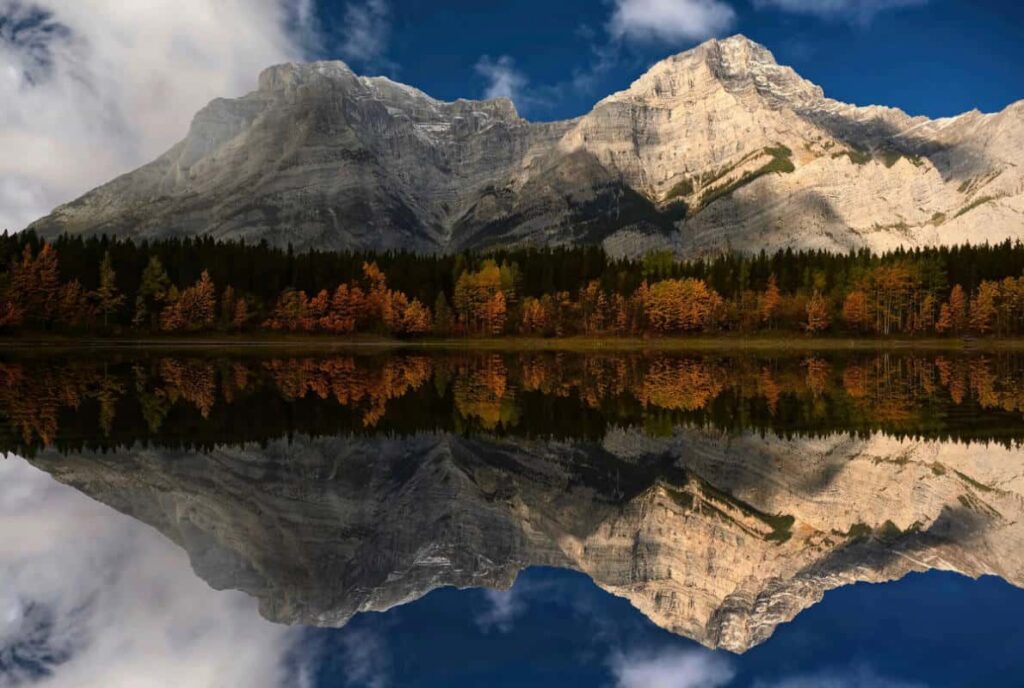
top-left (608, 0), bottom-right (736, 43)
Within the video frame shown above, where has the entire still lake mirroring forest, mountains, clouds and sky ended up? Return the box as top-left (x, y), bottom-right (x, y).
top-left (0, 347), bottom-right (1024, 688)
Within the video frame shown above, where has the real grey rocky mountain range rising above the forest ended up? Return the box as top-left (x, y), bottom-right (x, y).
top-left (22, 36), bottom-right (1024, 255)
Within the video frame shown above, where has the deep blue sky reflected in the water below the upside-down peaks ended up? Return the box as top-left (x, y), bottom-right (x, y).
top-left (304, 568), bottom-right (1024, 688)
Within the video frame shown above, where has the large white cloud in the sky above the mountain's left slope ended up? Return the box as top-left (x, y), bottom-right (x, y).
top-left (0, 0), bottom-right (318, 229)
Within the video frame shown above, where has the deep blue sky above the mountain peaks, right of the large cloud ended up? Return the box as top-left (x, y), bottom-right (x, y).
top-left (315, 0), bottom-right (1024, 119)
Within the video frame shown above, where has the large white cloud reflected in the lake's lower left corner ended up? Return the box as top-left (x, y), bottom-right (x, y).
top-left (0, 458), bottom-right (309, 688)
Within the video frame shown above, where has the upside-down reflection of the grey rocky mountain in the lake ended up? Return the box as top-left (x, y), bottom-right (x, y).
top-left (34, 430), bottom-right (1024, 652)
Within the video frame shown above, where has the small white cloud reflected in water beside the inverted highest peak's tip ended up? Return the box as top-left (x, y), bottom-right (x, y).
top-left (611, 650), bottom-right (735, 688)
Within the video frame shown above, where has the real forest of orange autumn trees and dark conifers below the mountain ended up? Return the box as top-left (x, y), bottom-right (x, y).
top-left (0, 232), bottom-right (1024, 338)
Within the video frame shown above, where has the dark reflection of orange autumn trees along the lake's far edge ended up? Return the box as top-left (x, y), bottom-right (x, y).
top-left (6, 351), bottom-right (1024, 456)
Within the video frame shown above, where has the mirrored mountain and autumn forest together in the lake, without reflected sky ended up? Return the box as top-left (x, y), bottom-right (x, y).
top-left (0, 352), bottom-right (1024, 685)
